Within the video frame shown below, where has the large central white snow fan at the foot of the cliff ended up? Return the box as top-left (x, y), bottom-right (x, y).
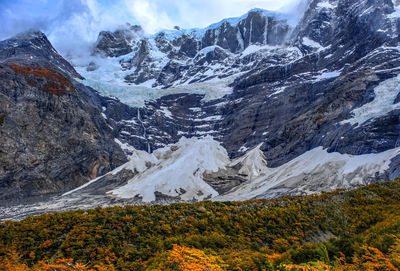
top-left (110, 137), bottom-right (229, 202)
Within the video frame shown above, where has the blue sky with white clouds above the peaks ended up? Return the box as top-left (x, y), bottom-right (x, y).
top-left (0, 0), bottom-right (299, 55)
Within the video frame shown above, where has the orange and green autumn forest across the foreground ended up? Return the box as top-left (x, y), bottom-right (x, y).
top-left (0, 180), bottom-right (400, 271)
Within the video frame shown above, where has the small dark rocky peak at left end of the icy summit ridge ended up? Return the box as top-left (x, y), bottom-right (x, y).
top-left (94, 24), bottom-right (143, 57)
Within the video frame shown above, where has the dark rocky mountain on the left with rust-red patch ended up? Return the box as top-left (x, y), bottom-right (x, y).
top-left (0, 33), bottom-right (126, 205)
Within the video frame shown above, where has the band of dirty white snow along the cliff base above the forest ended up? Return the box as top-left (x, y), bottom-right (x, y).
top-left (8, 137), bottom-right (400, 219)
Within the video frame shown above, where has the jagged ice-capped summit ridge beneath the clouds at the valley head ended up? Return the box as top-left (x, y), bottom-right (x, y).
top-left (74, 9), bottom-right (298, 88)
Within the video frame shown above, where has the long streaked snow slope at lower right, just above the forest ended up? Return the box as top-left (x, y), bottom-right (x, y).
top-left (214, 147), bottom-right (400, 201)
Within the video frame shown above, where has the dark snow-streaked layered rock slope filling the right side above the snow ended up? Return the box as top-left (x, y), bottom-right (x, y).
top-left (80, 0), bottom-right (399, 163)
